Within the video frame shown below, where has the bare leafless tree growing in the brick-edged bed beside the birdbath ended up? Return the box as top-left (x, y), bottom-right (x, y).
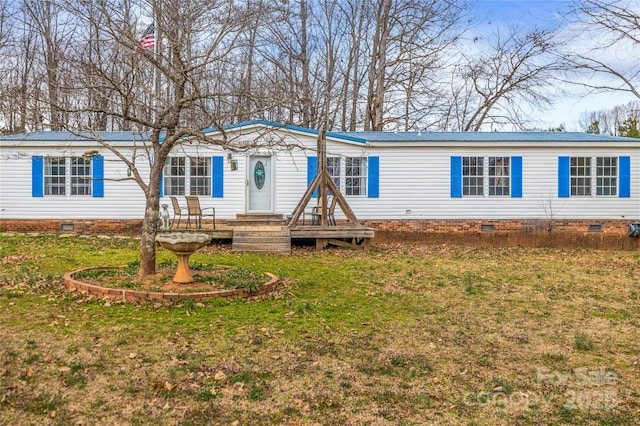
top-left (55, 0), bottom-right (255, 276)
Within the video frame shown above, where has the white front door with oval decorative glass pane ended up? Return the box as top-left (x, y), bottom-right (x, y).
top-left (247, 155), bottom-right (273, 213)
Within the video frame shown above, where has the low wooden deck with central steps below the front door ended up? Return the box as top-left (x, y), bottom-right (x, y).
top-left (165, 215), bottom-right (375, 254)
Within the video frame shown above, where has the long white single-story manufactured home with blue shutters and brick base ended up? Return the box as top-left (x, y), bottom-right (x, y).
top-left (0, 121), bottom-right (640, 246)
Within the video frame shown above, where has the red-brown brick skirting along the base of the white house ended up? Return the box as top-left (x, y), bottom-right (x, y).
top-left (0, 219), bottom-right (640, 249)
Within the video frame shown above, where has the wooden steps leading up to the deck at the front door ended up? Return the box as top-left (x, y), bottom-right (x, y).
top-left (231, 226), bottom-right (291, 255)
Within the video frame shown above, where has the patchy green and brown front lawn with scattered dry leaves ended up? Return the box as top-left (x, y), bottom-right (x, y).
top-left (0, 236), bottom-right (640, 425)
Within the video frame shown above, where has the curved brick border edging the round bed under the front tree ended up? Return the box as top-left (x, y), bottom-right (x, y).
top-left (64, 266), bottom-right (280, 303)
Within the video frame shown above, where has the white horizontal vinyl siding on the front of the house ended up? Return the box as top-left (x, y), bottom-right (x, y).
top-left (0, 128), bottom-right (640, 221)
